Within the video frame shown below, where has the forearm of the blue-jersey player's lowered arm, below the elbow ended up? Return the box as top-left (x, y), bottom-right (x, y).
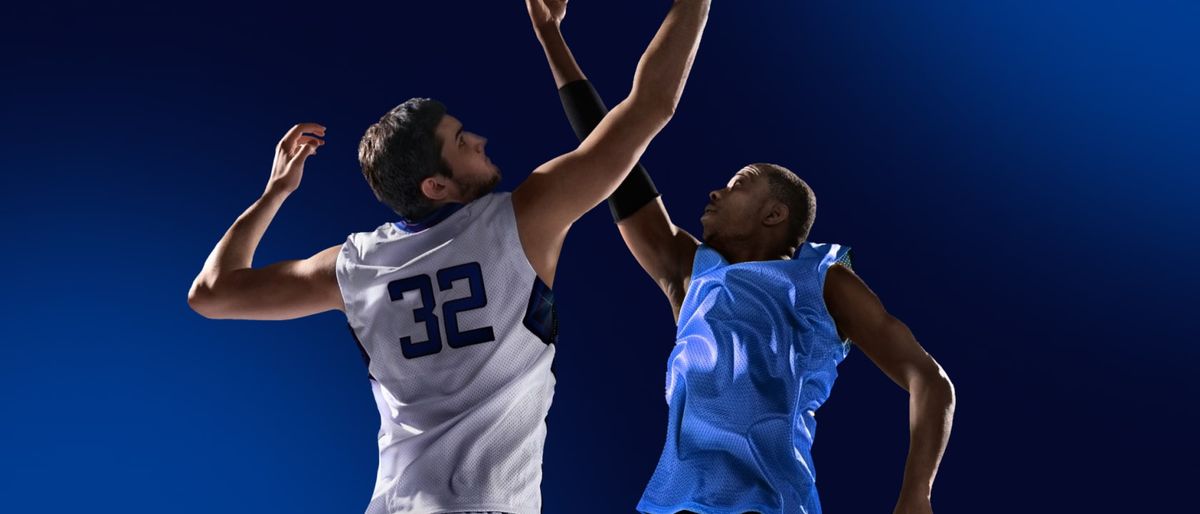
top-left (900, 366), bottom-right (955, 498)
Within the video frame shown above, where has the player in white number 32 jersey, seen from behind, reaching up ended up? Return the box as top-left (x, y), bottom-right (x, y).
top-left (188, 0), bottom-right (709, 514)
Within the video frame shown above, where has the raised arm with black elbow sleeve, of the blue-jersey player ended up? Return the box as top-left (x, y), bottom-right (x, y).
top-left (526, 0), bottom-right (700, 317)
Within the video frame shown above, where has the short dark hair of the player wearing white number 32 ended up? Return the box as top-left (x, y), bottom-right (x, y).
top-left (359, 98), bottom-right (451, 220)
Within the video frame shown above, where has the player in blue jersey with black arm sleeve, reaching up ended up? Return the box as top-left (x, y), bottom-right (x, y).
top-left (527, 0), bottom-right (954, 514)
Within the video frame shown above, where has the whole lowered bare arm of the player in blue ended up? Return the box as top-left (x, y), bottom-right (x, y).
top-left (824, 265), bottom-right (955, 513)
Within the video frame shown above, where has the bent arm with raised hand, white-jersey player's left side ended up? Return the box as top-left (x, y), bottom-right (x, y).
top-left (187, 124), bottom-right (344, 319)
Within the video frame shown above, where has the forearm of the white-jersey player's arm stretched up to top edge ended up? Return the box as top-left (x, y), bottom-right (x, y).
top-left (630, 0), bottom-right (710, 114)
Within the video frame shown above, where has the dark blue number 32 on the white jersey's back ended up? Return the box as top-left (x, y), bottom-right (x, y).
top-left (388, 262), bottom-right (496, 359)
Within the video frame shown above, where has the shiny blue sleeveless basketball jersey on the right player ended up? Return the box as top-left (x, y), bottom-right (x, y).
top-left (637, 244), bottom-right (850, 514)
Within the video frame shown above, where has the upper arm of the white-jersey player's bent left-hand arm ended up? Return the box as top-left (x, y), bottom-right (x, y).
top-left (204, 246), bottom-right (346, 319)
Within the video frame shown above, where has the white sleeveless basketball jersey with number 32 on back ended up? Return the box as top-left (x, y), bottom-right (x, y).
top-left (337, 193), bottom-right (557, 514)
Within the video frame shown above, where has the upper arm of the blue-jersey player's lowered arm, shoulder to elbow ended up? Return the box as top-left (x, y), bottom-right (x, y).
top-left (824, 265), bottom-right (938, 389)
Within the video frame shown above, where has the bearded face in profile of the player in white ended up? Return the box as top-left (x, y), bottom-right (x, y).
top-left (421, 114), bottom-right (500, 203)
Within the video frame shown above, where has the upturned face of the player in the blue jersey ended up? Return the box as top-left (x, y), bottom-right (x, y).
top-left (700, 166), bottom-right (787, 245)
